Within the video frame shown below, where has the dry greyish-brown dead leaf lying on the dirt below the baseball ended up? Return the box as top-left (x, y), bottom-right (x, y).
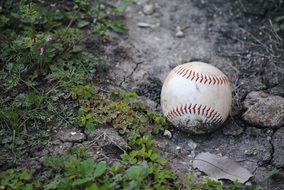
top-left (193, 152), bottom-right (253, 183)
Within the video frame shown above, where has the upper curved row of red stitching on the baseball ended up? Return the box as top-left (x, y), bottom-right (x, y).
top-left (174, 66), bottom-right (230, 85)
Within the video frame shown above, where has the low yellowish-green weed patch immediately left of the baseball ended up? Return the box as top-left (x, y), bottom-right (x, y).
top-left (72, 88), bottom-right (168, 134)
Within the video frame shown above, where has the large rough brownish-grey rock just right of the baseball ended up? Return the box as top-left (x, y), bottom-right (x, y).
top-left (243, 91), bottom-right (284, 128)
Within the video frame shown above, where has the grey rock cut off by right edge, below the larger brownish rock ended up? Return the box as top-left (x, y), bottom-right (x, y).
top-left (272, 127), bottom-right (284, 167)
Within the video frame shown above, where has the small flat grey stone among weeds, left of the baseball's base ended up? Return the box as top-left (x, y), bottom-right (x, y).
top-left (56, 128), bottom-right (86, 142)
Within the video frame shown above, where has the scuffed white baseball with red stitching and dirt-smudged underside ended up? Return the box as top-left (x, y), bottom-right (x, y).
top-left (161, 62), bottom-right (232, 134)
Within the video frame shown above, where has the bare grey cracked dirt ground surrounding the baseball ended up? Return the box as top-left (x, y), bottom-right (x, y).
top-left (96, 0), bottom-right (284, 189)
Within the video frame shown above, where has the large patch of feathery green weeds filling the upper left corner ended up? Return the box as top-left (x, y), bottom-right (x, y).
top-left (0, 0), bottom-right (127, 167)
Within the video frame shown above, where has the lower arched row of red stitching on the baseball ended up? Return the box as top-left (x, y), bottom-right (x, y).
top-left (166, 104), bottom-right (223, 123)
